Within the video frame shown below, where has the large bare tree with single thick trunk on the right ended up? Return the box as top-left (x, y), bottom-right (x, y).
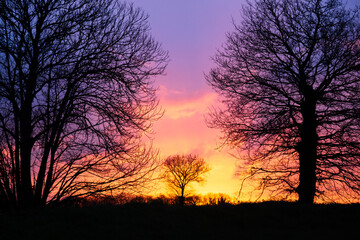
top-left (207, 0), bottom-right (360, 203)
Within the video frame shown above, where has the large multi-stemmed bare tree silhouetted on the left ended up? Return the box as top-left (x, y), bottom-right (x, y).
top-left (0, 0), bottom-right (168, 205)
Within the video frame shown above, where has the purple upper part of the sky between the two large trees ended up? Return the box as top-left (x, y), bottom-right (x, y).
top-left (133, 0), bottom-right (245, 94)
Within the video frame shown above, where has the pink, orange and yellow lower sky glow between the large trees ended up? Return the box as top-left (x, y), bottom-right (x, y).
top-left (153, 86), bottom-right (240, 196)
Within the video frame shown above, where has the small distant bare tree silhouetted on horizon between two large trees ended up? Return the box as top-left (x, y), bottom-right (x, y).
top-left (164, 154), bottom-right (210, 205)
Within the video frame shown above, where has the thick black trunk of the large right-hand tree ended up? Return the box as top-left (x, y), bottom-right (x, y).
top-left (297, 89), bottom-right (318, 204)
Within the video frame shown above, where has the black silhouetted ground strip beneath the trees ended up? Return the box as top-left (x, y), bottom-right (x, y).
top-left (0, 202), bottom-right (360, 240)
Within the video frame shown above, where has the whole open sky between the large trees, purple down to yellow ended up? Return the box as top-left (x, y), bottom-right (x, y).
top-left (132, 0), bottom-right (360, 199)
